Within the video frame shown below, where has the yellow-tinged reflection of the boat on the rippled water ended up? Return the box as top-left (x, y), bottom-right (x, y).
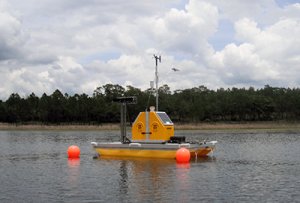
top-left (96, 157), bottom-right (216, 202)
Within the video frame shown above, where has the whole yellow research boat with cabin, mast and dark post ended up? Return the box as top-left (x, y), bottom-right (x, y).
top-left (91, 55), bottom-right (217, 159)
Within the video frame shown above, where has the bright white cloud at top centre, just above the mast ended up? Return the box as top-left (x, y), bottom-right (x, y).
top-left (144, 0), bottom-right (218, 55)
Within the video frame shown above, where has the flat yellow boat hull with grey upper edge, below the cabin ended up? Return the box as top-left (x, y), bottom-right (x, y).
top-left (92, 142), bottom-right (215, 159)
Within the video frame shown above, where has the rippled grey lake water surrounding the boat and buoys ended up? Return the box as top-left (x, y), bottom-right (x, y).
top-left (0, 131), bottom-right (300, 202)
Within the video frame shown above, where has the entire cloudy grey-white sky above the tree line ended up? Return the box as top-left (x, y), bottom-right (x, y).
top-left (0, 0), bottom-right (300, 99)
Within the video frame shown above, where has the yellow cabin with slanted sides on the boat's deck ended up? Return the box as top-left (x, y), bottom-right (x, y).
top-left (132, 111), bottom-right (174, 142)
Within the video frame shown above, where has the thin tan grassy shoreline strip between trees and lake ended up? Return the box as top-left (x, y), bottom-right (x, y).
top-left (0, 121), bottom-right (300, 132)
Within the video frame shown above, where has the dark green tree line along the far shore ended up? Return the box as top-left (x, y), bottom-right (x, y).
top-left (0, 84), bottom-right (300, 124)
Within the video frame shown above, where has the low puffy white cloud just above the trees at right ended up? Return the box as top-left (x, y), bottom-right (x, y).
top-left (214, 43), bottom-right (279, 85)
